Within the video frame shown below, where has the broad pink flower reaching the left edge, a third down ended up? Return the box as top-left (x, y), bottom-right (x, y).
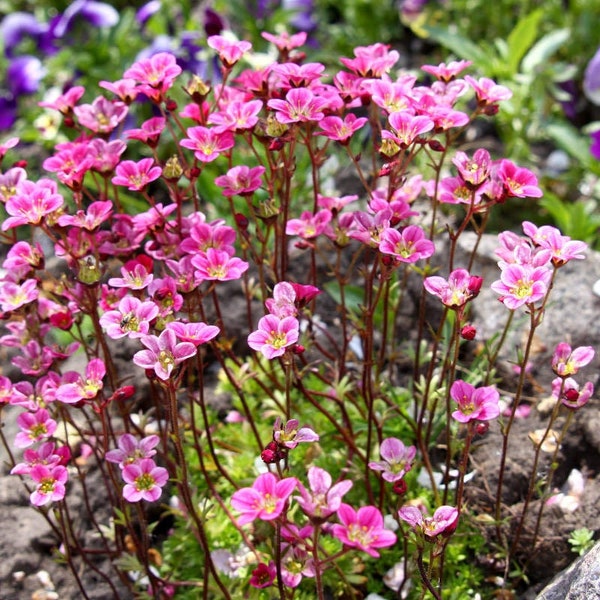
top-left (2, 178), bottom-right (64, 231)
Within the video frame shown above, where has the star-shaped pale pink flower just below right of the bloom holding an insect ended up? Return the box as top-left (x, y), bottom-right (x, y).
top-left (133, 329), bottom-right (197, 381)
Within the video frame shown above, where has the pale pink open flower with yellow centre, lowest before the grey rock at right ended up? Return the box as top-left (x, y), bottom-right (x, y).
top-left (490, 264), bottom-right (552, 310)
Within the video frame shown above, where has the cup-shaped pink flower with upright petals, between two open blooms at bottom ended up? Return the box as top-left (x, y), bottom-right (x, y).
top-left (295, 466), bottom-right (352, 521)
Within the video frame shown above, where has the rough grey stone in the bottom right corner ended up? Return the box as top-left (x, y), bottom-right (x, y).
top-left (536, 543), bottom-right (600, 600)
